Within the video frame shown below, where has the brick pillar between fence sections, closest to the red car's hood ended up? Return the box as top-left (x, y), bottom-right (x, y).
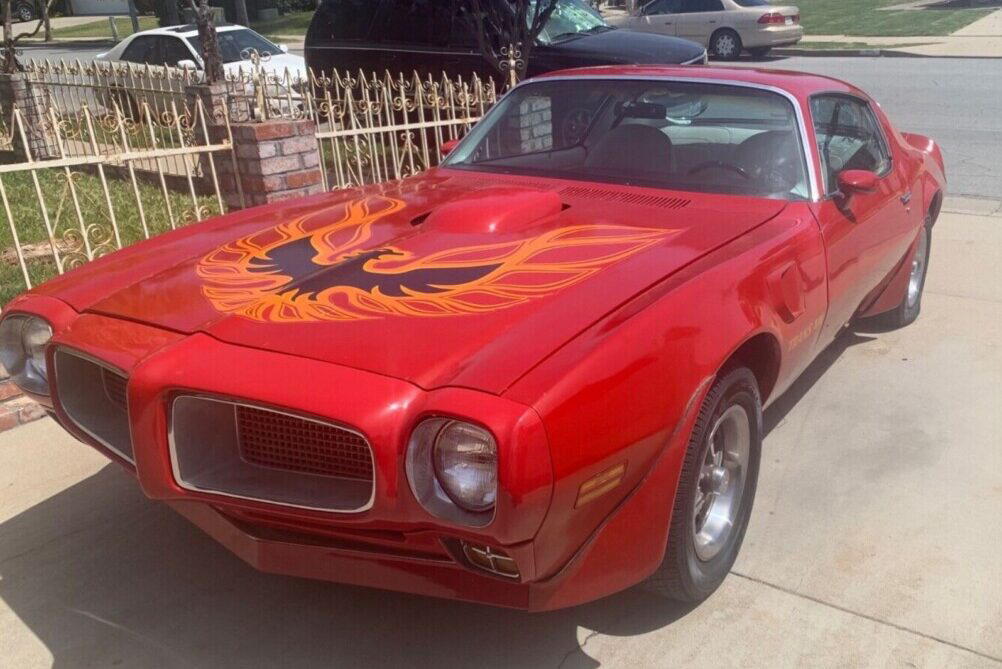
top-left (215, 120), bottom-right (324, 209)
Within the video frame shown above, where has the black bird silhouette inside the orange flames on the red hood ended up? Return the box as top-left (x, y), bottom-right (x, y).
top-left (247, 237), bottom-right (501, 297)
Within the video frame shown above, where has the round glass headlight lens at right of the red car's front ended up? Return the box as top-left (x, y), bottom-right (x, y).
top-left (432, 421), bottom-right (498, 512)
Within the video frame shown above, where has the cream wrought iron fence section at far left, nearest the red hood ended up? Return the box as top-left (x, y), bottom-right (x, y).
top-left (0, 98), bottom-right (241, 303)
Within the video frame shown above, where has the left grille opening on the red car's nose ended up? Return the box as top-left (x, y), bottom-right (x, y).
top-left (54, 348), bottom-right (133, 462)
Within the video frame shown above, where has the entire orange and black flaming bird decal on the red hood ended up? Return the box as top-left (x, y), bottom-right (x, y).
top-left (196, 196), bottom-right (677, 322)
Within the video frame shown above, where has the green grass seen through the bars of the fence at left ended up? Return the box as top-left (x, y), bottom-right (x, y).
top-left (0, 169), bottom-right (218, 305)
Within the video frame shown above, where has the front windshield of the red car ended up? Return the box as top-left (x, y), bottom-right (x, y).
top-left (443, 78), bottom-right (810, 199)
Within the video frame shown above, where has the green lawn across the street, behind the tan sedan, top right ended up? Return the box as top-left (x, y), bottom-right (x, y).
top-left (785, 0), bottom-right (991, 37)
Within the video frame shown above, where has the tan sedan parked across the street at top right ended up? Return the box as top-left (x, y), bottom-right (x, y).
top-left (607, 0), bottom-right (804, 60)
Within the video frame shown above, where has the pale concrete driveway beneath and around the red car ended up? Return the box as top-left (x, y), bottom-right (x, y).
top-left (0, 200), bottom-right (1002, 669)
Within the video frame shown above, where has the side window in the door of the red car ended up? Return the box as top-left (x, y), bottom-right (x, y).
top-left (811, 95), bottom-right (891, 193)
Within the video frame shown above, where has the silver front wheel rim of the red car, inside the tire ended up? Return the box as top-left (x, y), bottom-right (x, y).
top-left (692, 405), bottom-right (752, 562)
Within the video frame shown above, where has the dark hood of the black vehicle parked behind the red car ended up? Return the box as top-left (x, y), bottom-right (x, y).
top-left (549, 28), bottom-right (705, 65)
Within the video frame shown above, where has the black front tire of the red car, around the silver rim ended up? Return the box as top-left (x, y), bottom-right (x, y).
top-left (643, 368), bottom-right (763, 604)
